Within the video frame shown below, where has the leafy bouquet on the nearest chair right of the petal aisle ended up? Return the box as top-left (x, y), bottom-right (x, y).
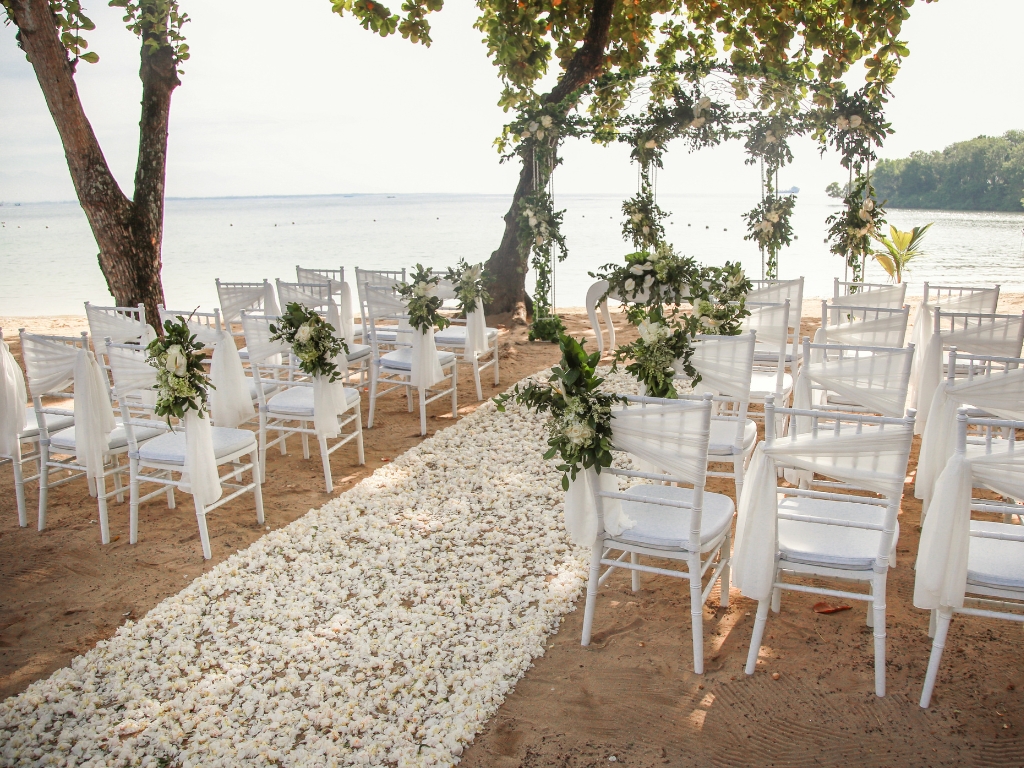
top-left (495, 334), bottom-right (626, 490)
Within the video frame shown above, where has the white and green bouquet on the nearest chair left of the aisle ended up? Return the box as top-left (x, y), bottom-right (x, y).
top-left (145, 314), bottom-right (214, 426)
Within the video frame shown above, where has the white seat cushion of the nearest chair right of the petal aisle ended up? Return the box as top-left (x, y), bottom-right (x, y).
top-left (614, 485), bottom-right (733, 550)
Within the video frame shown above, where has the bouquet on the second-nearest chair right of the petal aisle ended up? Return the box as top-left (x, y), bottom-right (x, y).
top-left (611, 307), bottom-right (700, 399)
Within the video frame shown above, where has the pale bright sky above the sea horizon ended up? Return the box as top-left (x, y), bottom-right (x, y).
top-left (0, 0), bottom-right (1024, 203)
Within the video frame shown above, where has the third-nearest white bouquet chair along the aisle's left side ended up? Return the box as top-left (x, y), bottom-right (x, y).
top-left (362, 283), bottom-right (459, 435)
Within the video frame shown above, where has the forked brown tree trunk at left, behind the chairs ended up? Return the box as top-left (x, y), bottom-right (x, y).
top-left (8, 0), bottom-right (179, 330)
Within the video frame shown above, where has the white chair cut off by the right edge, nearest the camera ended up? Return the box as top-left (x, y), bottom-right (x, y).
top-left (913, 409), bottom-right (1024, 708)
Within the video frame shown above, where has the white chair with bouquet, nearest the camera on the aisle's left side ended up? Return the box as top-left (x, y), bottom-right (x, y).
top-left (106, 341), bottom-right (263, 560)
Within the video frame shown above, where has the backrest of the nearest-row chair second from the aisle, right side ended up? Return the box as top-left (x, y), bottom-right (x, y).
top-left (764, 395), bottom-right (914, 564)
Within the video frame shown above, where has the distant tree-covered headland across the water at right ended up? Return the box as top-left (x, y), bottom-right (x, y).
top-left (825, 131), bottom-right (1024, 212)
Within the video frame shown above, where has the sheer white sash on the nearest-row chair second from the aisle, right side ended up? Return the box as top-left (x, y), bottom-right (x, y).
top-left (732, 425), bottom-right (911, 600)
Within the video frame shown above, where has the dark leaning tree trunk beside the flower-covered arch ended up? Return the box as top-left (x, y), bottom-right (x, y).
top-left (485, 0), bottom-right (614, 325)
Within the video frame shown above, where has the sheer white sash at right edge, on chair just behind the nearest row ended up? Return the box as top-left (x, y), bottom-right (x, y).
top-left (913, 368), bottom-right (1024, 516)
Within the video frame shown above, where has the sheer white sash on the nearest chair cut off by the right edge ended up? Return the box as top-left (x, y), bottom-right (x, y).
top-left (913, 451), bottom-right (1024, 610)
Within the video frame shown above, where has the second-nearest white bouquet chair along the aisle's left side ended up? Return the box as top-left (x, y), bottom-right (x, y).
top-left (242, 312), bottom-right (366, 494)
